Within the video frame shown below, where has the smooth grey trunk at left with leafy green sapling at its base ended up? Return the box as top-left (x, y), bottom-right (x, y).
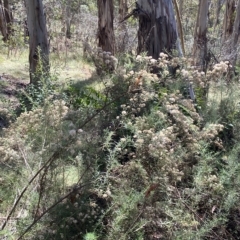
top-left (26, 0), bottom-right (49, 84)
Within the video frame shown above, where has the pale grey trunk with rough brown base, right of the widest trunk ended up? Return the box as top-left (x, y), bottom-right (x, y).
top-left (193, 0), bottom-right (209, 71)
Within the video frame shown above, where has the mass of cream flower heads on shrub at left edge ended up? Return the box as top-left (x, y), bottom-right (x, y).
top-left (0, 100), bottom-right (69, 161)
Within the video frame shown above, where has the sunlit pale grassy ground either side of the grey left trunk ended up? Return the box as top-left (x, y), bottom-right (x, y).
top-left (0, 49), bottom-right (94, 129)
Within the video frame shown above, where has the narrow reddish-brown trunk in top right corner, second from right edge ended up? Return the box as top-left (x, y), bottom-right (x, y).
top-left (222, 0), bottom-right (236, 43)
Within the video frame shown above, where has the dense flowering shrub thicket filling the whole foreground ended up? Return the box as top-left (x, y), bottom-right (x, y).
top-left (0, 53), bottom-right (240, 240)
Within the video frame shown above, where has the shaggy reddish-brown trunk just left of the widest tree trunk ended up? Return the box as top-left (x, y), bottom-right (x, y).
top-left (97, 0), bottom-right (115, 55)
